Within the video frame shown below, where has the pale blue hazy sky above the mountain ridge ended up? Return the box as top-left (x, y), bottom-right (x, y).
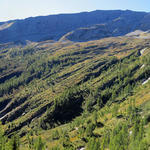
top-left (0, 0), bottom-right (150, 21)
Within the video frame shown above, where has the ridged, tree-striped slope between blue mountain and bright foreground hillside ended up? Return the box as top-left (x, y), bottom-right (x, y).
top-left (0, 37), bottom-right (150, 139)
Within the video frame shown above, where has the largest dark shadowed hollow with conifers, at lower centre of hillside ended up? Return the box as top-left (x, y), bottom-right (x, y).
top-left (41, 86), bottom-right (84, 128)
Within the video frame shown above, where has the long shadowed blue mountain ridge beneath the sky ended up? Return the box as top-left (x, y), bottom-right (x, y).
top-left (0, 10), bottom-right (150, 43)
